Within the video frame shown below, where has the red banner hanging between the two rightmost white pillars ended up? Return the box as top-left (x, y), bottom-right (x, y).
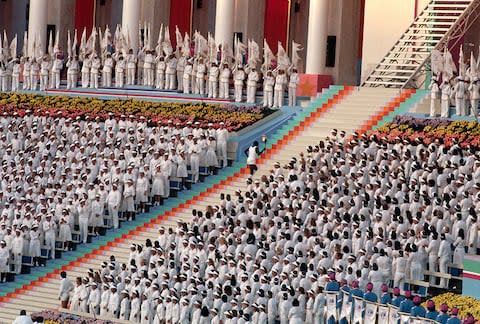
top-left (263, 0), bottom-right (290, 54)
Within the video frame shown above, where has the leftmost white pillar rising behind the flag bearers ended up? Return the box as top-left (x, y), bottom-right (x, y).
top-left (27, 0), bottom-right (48, 56)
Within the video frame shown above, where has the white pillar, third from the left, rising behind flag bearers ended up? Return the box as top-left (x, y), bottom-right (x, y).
top-left (215, 0), bottom-right (235, 47)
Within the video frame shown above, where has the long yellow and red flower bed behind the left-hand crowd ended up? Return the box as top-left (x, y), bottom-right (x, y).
top-left (0, 93), bottom-right (273, 131)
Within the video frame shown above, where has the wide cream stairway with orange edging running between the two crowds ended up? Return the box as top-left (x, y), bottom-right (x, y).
top-left (0, 88), bottom-right (411, 323)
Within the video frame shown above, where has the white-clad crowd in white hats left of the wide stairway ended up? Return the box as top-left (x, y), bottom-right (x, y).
top-left (0, 111), bottom-right (229, 282)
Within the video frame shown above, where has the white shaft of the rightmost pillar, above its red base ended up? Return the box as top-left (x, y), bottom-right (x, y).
top-left (306, 0), bottom-right (328, 74)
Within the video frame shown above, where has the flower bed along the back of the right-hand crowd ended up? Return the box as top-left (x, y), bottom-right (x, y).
top-left (371, 116), bottom-right (480, 148)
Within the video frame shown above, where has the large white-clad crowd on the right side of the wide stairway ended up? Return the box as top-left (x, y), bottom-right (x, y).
top-left (61, 131), bottom-right (480, 323)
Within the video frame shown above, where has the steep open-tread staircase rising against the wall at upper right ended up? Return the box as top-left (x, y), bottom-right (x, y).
top-left (363, 0), bottom-right (480, 88)
